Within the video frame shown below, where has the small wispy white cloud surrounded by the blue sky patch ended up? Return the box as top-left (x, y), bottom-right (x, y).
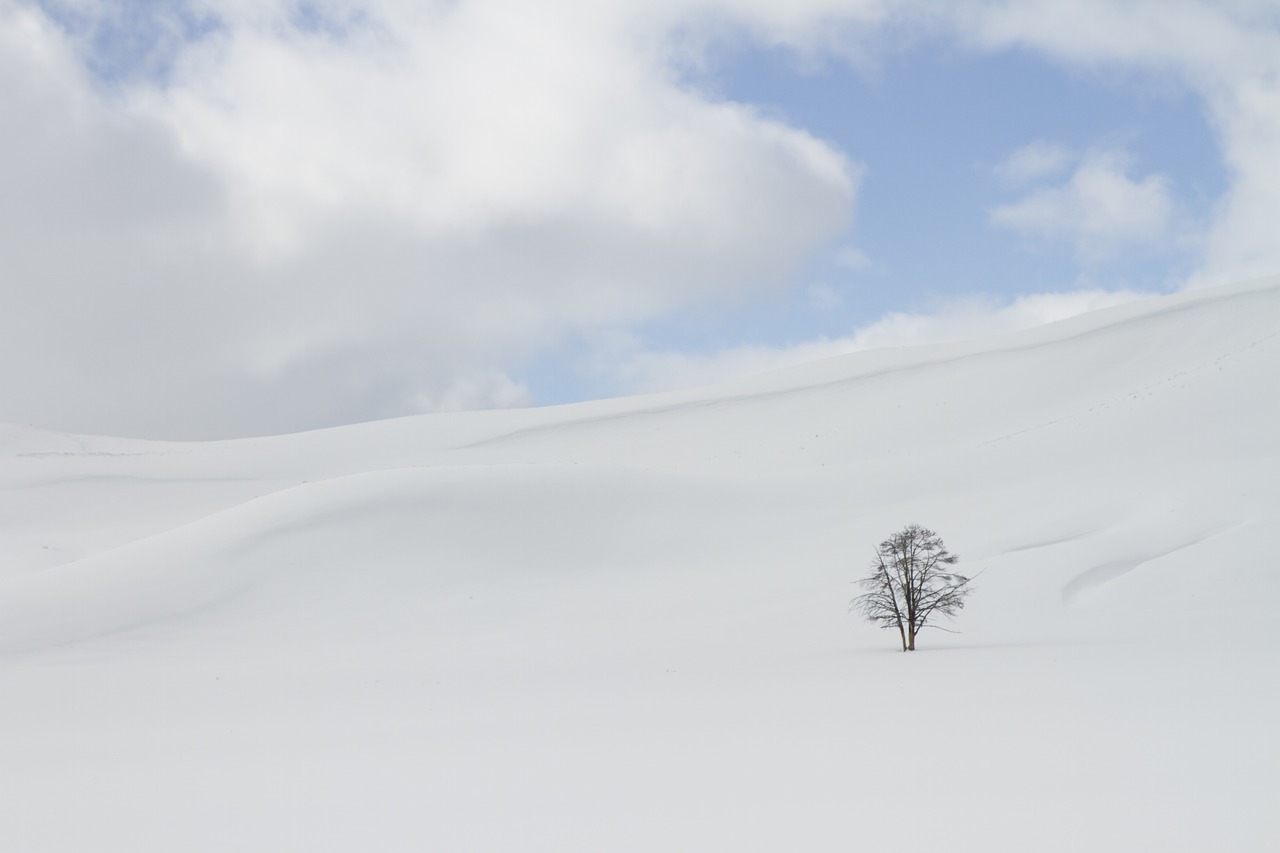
top-left (991, 151), bottom-right (1172, 259)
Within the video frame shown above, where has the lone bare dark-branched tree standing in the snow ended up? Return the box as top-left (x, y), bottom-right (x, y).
top-left (849, 524), bottom-right (969, 652)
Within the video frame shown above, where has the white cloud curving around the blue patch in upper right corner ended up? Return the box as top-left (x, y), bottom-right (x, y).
top-left (954, 0), bottom-right (1280, 284)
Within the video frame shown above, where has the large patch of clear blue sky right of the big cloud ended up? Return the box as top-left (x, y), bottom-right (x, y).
top-left (723, 42), bottom-right (1225, 302)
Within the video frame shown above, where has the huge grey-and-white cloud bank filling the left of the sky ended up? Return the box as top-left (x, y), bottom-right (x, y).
top-left (0, 1), bottom-right (858, 438)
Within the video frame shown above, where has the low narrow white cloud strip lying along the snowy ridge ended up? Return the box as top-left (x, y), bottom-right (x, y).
top-left (618, 285), bottom-right (1151, 393)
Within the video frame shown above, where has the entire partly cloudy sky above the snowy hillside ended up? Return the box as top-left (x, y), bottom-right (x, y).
top-left (0, 0), bottom-right (1280, 439)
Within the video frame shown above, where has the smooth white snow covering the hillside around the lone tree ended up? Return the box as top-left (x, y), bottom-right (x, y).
top-left (0, 279), bottom-right (1280, 853)
